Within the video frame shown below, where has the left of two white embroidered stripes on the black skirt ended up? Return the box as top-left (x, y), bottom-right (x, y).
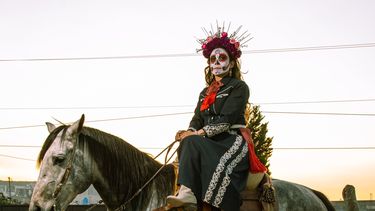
top-left (203, 136), bottom-right (242, 203)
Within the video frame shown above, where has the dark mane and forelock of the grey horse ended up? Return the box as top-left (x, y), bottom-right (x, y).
top-left (38, 125), bottom-right (175, 210)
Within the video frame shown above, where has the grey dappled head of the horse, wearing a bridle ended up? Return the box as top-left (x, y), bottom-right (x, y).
top-left (29, 115), bottom-right (91, 211)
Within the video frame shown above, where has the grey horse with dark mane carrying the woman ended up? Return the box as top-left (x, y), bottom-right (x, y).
top-left (29, 115), bottom-right (334, 211)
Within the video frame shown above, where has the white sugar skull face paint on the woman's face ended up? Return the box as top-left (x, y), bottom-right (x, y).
top-left (210, 48), bottom-right (230, 75)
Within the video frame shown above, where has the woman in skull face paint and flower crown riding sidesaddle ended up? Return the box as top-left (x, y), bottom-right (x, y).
top-left (167, 23), bottom-right (266, 211)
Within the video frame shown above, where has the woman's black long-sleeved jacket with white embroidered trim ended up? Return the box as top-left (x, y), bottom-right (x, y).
top-left (189, 77), bottom-right (249, 137)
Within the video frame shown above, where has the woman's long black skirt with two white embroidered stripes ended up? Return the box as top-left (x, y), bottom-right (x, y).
top-left (178, 133), bottom-right (249, 211)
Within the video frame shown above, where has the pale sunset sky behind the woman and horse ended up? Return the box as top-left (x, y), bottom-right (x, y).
top-left (0, 0), bottom-right (375, 200)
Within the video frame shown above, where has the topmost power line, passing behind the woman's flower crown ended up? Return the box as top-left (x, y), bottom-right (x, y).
top-left (0, 43), bottom-right (375, 62)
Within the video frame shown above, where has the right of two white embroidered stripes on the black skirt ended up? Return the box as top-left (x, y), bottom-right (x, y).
top-left (212, 144), bottom-right (249, 207)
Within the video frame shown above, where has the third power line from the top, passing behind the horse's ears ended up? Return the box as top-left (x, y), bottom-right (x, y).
top-left (0, 111), bottom-right (375, 130)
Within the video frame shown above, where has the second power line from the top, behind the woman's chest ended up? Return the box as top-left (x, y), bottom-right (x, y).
top-left (0, 98), bottom-right (375, 110)
